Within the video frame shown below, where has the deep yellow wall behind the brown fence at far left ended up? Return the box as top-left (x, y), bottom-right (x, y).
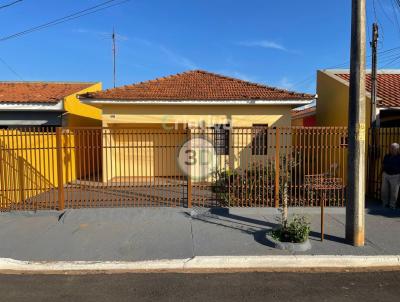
top-left (0, 130), bottom-right (76, 208)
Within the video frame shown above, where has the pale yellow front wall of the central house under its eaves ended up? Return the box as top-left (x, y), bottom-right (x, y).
top-left (98, 105), bottom-right (292, 181)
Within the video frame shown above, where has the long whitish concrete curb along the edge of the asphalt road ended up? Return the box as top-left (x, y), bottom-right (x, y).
top-left (0, 255), bottom-right (400, 273)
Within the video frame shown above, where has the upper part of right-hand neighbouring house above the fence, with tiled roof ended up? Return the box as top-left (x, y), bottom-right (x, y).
top-left (316, 69), bottom-right (400, 129)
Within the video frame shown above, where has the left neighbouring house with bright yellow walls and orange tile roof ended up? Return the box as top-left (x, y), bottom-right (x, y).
top-left (0, 82), bottom-right (101, 208)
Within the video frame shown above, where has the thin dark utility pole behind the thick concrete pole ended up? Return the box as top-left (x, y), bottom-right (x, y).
top-left (371, 23), bottom-right (380, 128)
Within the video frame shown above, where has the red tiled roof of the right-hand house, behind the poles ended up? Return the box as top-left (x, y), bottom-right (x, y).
top-left (335, 70), bottom-right (400, 107)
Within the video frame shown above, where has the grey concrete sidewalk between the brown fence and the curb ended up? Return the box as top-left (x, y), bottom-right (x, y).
top-left (0, 207), bottom-right (400, 261)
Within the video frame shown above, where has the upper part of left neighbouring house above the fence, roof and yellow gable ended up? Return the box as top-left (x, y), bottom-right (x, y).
top-left (0, 82), bottom-right (101, 129)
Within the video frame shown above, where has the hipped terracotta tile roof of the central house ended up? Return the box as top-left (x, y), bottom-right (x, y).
top-left (81, 70), bottom-right (315, 101)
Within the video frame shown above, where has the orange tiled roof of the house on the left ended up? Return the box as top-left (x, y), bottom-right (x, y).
top-left (0, 82), bottom-right (94, 104)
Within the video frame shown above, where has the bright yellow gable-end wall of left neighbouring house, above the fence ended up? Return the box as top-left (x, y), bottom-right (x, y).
top-left (64, 83), bottom-right (102, 127)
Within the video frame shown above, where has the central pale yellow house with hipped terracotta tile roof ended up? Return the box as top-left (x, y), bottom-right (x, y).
top-left (80, 70), bottom-right (315, 181)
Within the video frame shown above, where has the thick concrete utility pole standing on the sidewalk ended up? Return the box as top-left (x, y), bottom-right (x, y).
top-left (346, 0), bottom-right (366, 246)
